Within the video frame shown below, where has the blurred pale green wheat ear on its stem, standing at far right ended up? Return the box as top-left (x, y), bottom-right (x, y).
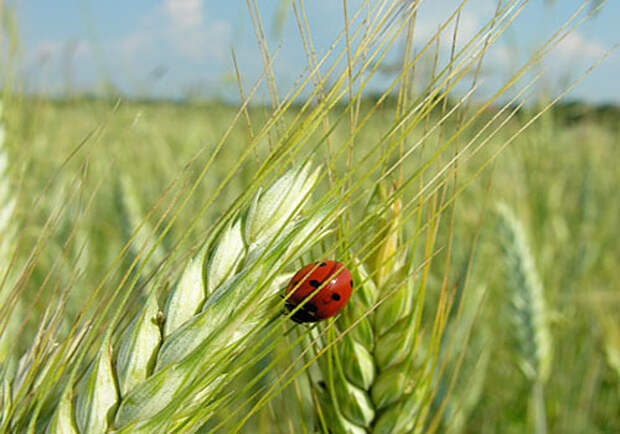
top-left (498, 204), bottom-right (551, 434)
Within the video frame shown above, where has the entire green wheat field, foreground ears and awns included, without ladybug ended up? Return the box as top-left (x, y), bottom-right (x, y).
top-left (0, 1), bottom-right (620, 434)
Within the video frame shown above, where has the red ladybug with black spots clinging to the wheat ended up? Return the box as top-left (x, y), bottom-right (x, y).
top-left (285, 261), bottom-right (353, 323)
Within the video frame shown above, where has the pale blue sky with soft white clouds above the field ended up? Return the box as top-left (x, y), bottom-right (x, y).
top-left (14, 0), bottom-right (620, 103)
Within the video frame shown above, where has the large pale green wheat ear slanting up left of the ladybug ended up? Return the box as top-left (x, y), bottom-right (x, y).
top-left (40, 164), bottom-right (327, 432)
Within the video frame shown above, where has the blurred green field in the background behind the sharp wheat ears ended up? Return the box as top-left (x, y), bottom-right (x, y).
top-left (3, 2), bottom-right (620, 433)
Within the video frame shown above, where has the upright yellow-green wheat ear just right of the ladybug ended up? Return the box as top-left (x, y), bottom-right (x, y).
top-left (319, 187), bottom-right (428, 433)
